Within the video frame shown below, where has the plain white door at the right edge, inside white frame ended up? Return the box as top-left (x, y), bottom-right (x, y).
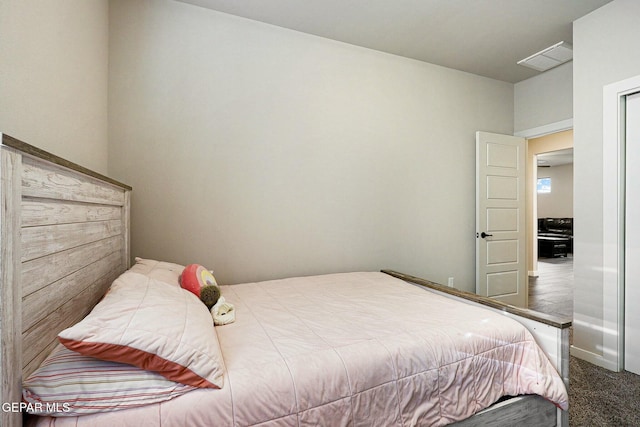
top-left (624, 93), bottom-right (640, 374)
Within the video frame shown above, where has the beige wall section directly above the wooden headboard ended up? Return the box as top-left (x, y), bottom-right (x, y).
top-left (0, 0), bottom-right (109, 173)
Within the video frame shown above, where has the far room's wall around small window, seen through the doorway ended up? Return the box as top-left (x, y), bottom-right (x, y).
top-left (538, 164), bottom-right (573, 218)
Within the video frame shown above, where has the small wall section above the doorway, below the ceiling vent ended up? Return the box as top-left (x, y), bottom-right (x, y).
top-left (513, 62), bottom-right (573, 133)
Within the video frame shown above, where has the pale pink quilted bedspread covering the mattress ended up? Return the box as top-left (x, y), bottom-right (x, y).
top-left (32, 273), bottom-right (568, 427)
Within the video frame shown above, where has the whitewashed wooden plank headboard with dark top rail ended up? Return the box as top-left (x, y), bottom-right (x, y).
top-left (0, 134), bottom-right (131, 427)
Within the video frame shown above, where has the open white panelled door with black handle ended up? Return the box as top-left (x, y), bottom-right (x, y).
top-left (476, 132), bottom-right (528, 308)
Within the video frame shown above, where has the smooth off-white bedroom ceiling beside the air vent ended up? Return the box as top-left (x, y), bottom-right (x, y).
top-left (178, 0), bottom-right (611, 83)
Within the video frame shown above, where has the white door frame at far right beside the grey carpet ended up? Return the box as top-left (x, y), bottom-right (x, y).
top-left (602, 76), bottom-right (640, 371)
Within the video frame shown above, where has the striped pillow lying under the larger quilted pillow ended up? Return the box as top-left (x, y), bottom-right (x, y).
top-left (22, 344), bottom-right (197, 417)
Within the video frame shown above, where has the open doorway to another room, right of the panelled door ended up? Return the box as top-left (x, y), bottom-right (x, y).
top-left (527, 130), bottom-right (574, 318)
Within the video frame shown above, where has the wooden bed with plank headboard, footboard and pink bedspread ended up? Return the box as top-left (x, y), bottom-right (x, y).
top-left (0, 135), bottom-right (570, 426)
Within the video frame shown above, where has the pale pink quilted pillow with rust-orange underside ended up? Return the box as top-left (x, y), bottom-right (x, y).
top-left (58, 271), bottom-right (224, 388)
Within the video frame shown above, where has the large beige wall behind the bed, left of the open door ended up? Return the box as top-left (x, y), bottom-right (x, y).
top-left (109, 0), bottom-right (513, 290)
